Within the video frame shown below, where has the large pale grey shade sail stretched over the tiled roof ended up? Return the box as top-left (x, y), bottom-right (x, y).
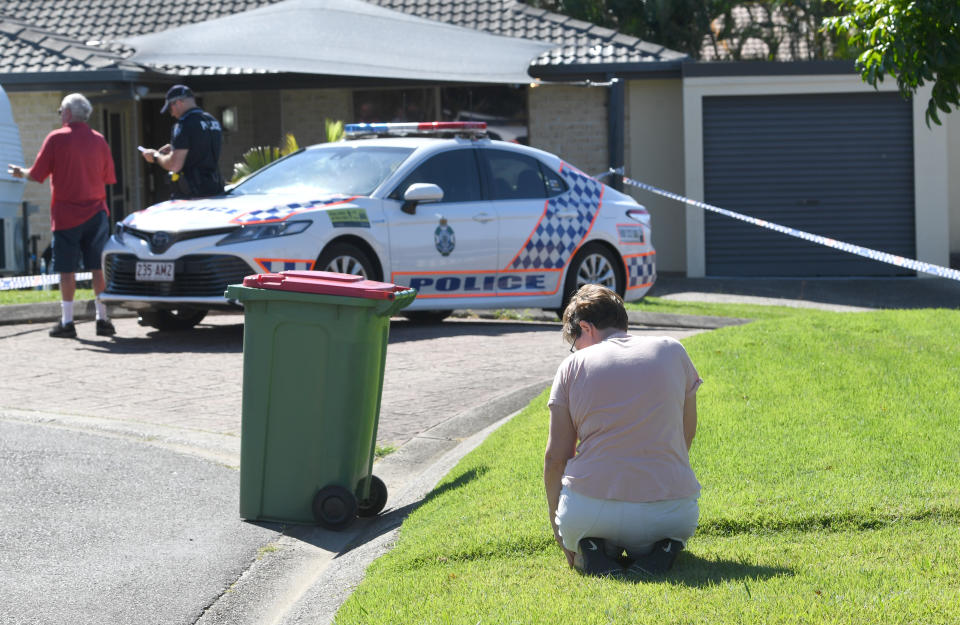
top-left (122, 0), bottom-right (552, 84)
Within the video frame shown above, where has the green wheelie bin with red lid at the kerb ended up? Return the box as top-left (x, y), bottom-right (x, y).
top-left (225, 271), bottom-right (416, 529)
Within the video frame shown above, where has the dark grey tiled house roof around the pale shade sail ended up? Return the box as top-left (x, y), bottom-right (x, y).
top-left (0, 0), bottom-right (688, 83)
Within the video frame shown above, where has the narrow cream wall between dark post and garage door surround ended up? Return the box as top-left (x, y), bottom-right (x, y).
top-left (624, 79), bottom-right (686, 273)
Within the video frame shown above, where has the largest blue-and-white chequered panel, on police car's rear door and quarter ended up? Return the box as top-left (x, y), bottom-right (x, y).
top-left (507, 167), bottom-right (603, 269)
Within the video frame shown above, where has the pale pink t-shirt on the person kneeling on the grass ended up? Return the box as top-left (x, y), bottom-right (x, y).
top-left (547, 332), bottom-right (702, 502)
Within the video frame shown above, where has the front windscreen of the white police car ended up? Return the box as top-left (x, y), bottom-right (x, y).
top-left (230, 144), bottom-right (413, 195)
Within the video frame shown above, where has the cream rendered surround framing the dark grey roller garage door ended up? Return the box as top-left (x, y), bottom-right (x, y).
top-left (683, 74), bottom-right (960, 277)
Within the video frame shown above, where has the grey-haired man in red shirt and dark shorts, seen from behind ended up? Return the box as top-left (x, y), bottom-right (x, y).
top-left (8, 93), bottom-right (117, 338)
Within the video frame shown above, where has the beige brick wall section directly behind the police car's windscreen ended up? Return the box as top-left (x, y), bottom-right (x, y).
top-left (281, 89), bottom-right (353, 147)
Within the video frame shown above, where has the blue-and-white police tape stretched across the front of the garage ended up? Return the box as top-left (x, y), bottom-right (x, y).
top-left (595, 169), bottom-right (960, 280)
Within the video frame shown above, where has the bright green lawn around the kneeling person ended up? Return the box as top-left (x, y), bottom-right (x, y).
top-left (336, 310), bottom-right (960, 625)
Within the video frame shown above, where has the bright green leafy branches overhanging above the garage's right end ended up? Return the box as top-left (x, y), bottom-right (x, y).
top-left (823, 0), bottom-right (960, 126)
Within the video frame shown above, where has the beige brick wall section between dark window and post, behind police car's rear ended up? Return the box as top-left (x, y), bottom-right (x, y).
top-left (528, 85), bottom-right (608, 174)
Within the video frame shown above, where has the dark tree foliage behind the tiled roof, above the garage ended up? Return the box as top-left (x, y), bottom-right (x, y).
top-left (527, 0), bottom-right (847, 61)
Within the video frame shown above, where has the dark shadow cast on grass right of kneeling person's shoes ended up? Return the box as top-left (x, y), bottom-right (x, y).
top-left (616, 551), bottom-right (794, 592)
